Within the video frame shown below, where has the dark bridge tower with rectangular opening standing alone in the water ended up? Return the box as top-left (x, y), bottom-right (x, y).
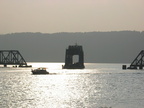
top-left (63, 44), bottom-right (85, 69)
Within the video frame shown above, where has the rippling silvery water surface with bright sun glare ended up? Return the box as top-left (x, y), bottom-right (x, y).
top-left (0, 63), bottom-right (144, 108)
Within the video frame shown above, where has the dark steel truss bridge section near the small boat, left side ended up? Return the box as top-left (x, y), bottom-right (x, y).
top-left (0, 50), bottom-right (32, 67)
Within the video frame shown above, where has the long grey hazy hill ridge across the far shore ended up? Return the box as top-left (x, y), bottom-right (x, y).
top-left (0, 31), bottom-right (144, 62)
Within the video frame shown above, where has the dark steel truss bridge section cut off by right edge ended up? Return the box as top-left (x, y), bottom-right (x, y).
top-left (129, 50), bottom-right (144, 69)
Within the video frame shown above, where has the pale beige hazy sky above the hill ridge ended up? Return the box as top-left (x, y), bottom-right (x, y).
top-left (0, 0), bottom-right (144, 34)
